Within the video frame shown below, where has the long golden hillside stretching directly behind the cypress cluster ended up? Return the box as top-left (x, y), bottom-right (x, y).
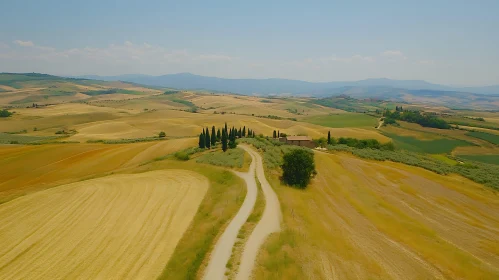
top-left (64, 107), bottom-right (389, 142)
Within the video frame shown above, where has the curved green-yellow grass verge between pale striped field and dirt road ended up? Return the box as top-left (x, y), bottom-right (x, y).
top-left (152, 160), bottom-right (246, 279)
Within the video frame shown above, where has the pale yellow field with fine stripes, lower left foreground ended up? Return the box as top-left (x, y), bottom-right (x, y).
top-left (0, 170), bottom-right (208, 279)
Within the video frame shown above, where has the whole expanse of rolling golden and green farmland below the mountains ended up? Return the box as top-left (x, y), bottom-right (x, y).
top-left (0, 74), bottom-right (499, 279)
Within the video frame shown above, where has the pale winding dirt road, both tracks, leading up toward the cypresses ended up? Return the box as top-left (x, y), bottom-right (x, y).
top-left (204, 145), bottom-right (282, 280)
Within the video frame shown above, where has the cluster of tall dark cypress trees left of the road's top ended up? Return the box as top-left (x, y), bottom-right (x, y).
top-left (199, 123), bottom-right (255, 152)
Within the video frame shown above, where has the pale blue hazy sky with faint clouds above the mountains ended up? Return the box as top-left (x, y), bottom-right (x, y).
top-left (0, 0), bottom-right (499, 86)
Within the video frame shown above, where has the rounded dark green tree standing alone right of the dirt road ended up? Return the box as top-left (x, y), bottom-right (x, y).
top-left (281, 149), bottom-right (316, 189)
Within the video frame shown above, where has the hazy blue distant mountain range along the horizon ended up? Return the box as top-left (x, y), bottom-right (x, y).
top-left (78, 73), bottom-right (499, 96)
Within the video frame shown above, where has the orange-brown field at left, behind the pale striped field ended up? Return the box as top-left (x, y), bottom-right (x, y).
top-left (0, 138), bottom-right (196, 202)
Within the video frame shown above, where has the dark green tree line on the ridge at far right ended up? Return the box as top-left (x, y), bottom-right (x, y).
top-left (383, 106), bottom-right (451, 129)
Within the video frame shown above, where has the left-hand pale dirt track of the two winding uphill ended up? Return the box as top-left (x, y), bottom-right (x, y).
top-left (203, 146), bottom-right (258, 280)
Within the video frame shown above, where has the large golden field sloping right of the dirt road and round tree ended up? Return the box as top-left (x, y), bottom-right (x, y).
top-left (256, 153), bottom-right (499, 279)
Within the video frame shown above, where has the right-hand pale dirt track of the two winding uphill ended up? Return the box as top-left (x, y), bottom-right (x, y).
top-left (236, 145), bottom-right (282, 280)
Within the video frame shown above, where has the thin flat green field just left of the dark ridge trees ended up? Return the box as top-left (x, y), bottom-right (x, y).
top-left (303, 113), bottom-right (378, 128)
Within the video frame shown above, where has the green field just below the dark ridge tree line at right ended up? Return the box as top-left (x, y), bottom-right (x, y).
top-left (383, 132), bottom-right (472, 154)
